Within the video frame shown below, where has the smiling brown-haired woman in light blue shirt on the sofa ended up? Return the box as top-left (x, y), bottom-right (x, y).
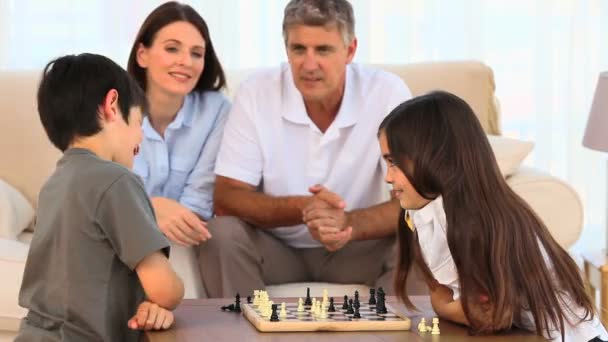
top-left (128, 2), bottom-right (230, 245)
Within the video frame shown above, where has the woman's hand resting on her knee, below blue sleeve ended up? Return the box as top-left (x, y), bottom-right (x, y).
top-left (152, 197), bottom-right (211, 246)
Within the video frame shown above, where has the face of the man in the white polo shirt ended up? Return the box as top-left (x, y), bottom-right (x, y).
top-left (287, 25), bottom-right (357, 101)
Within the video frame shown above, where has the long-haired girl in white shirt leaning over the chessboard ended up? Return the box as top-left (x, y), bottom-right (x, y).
top-left (379, 92), bottom-right (608, 342)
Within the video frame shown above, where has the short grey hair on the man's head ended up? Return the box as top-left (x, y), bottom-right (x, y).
top-left (283, 0), bottom-right (355, 45)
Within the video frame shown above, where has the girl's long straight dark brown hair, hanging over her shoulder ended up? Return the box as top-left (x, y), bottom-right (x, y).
top-left (380, 92), bottom-right (593, 338)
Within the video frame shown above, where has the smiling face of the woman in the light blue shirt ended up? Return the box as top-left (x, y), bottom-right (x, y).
top-left (137, 21), bottom-right (205, 96)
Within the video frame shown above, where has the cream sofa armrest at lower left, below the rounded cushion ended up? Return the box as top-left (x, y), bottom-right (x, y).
top-left (0, 239), bottom-right (29, 331)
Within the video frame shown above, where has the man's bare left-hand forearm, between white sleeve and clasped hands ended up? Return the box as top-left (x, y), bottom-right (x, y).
top-left (213, 176), bottom-right (312, 228)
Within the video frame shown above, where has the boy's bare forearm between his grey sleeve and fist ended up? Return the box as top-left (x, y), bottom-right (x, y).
top-left (135, 251), bottom-right (184, 310)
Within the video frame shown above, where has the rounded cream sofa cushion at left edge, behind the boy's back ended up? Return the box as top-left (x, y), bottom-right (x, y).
top-left (0, 179), bottom-right (34, 240)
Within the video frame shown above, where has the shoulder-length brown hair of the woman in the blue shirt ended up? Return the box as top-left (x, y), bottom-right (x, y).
top-left (127, 1), bottom-right (226, 91)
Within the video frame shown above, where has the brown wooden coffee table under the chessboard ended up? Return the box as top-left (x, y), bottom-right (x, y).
top-left (143, 296), bottom-right (545, 342)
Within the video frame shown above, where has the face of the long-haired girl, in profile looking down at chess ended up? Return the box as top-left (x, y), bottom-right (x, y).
top-left (379, 132), bottom-right (431, 209)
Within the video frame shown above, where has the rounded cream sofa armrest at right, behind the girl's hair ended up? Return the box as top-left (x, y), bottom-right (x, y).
top-left (507, 167), bottom-right (583, 250)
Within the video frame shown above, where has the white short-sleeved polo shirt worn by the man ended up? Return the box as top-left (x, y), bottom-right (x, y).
top-left (215, 64), bottom-right (411, 248)
